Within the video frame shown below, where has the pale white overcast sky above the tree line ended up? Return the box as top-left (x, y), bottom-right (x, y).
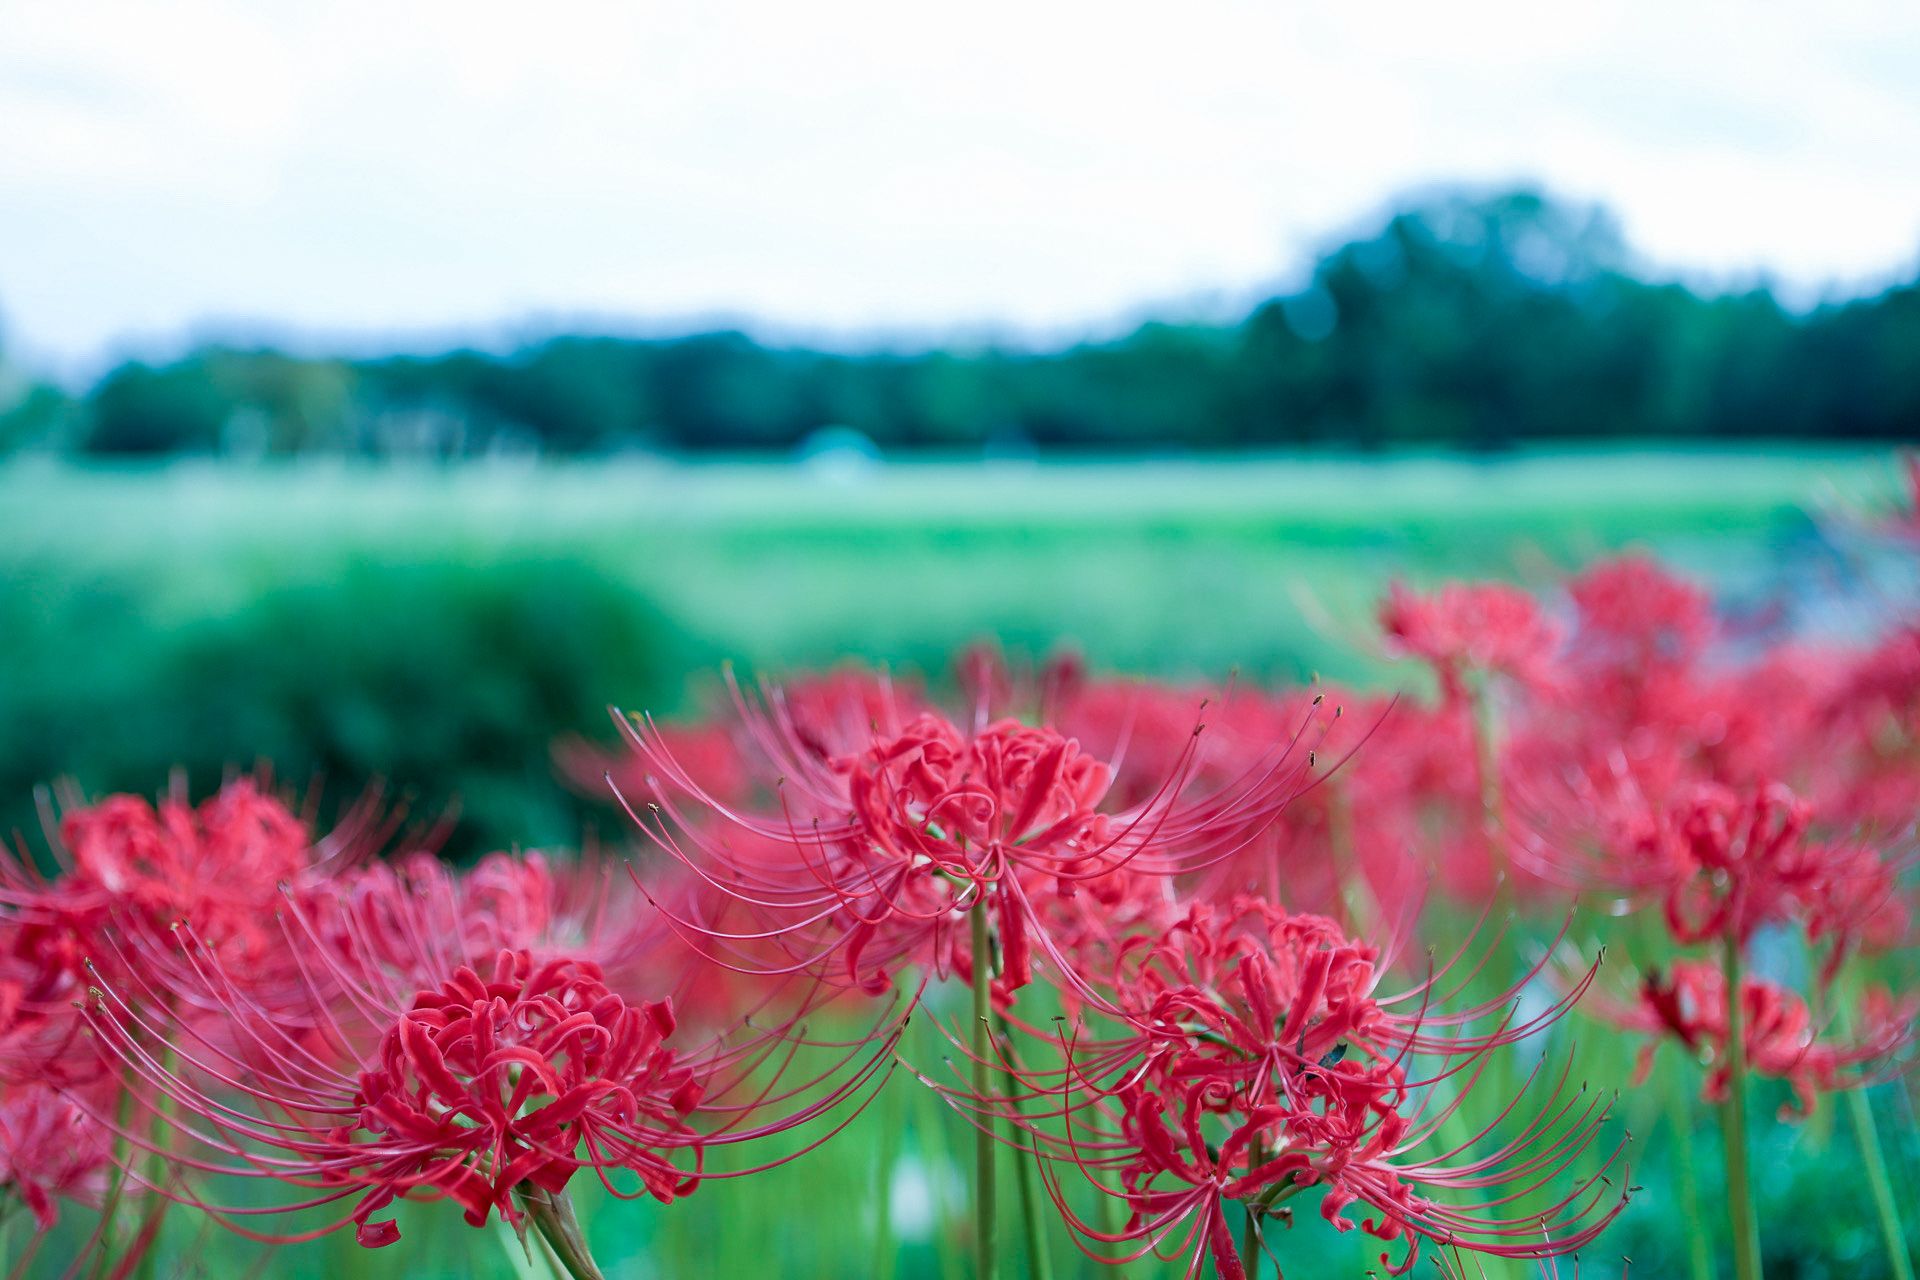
top-left (0, 0), bottom-right (1920, 368)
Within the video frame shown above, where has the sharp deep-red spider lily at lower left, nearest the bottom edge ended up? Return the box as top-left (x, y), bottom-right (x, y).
top-left (86, 952), bottom-right (699, 1245)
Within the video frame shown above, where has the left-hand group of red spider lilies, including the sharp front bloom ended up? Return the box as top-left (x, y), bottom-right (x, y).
top-left (0, 779), bottom-right (891, 1249)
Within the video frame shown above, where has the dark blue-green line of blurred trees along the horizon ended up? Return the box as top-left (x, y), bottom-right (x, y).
top-left (11, 192), bottom-right (1920, 455)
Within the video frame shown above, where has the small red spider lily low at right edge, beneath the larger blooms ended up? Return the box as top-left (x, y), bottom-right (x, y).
top-left (1594, 960), bottom-right (1920, 1119)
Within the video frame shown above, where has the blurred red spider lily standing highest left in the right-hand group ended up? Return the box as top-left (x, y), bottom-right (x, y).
top-left (1380, 581), bottom-right (1557, 697)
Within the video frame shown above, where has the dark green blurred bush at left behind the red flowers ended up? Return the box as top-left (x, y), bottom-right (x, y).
top-left (0, 560), bottom-right (660, 854)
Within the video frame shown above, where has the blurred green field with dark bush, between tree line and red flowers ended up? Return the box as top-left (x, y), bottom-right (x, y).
top-left (0, 449), bottom-right (1895, 854)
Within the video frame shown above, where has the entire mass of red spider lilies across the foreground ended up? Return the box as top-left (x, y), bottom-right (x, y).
top-left (0, 545), bottom-right (1920, 1280)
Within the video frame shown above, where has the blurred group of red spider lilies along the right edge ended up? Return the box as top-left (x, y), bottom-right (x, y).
top-left (1354, 557), bottom-right (1920, 1111)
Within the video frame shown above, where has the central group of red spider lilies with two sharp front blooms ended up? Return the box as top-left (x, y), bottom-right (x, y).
top-left (620, 666), bottom-right (1624, 1276)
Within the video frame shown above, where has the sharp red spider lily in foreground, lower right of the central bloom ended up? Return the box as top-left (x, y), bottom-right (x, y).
top-left (935, 896), bottom-right (1624, 1278)
